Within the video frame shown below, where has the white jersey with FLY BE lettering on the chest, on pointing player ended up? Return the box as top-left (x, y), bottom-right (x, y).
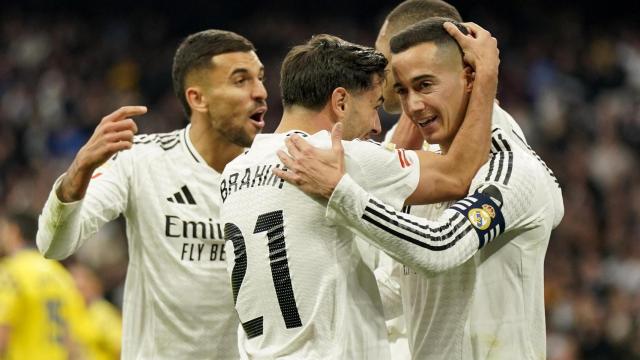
top-left (37, 127), bottom-right (238, 359)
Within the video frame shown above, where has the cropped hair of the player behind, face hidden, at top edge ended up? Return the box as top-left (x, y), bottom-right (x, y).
top-left (385, 0), bottom-right (462, 36)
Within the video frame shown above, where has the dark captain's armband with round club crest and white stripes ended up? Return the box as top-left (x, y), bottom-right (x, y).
top-left (451, 193), bottom-right (505, 249)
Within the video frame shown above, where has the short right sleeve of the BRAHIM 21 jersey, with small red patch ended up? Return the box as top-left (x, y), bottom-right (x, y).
top-left (344, 140), bottom-right (420, 209)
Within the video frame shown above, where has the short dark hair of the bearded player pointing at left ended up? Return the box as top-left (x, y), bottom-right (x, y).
top-left (171, 29), bottom-right (256, 117)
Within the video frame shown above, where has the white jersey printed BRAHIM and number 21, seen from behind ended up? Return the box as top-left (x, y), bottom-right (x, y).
top-left (220, 131), bottom-right (419, 359)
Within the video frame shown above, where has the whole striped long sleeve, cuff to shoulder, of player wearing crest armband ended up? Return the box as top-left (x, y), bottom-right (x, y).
top-left (327, 146), bottom-right (547, 272)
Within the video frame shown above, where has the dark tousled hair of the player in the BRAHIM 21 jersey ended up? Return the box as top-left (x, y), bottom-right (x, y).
top-left (280, 34), bottom-right (387, 110)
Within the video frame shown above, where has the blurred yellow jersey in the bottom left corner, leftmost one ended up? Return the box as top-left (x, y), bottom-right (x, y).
top-left (0, 249), bottom-right (87, 360)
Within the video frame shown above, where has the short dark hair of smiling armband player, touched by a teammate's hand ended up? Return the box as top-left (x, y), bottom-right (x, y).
top-left (389, 17), bottom-right (469, 54)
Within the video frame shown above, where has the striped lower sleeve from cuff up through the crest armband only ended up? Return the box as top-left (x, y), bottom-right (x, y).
top-left (327, 175), bottom-right (505, 272)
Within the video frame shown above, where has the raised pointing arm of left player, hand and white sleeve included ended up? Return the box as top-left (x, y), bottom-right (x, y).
top-left (36, 106), bottom-right (147, 259)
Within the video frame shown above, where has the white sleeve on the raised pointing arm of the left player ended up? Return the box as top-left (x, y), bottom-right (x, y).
top-left (36, 151), bottom-right (132, 259)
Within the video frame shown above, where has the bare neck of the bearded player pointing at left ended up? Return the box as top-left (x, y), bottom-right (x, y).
top-left (189, 120), bottom-right (244, 173)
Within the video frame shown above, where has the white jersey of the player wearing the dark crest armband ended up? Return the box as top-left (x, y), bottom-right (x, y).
top-left (328, 105), bottom-right (564, 359)
